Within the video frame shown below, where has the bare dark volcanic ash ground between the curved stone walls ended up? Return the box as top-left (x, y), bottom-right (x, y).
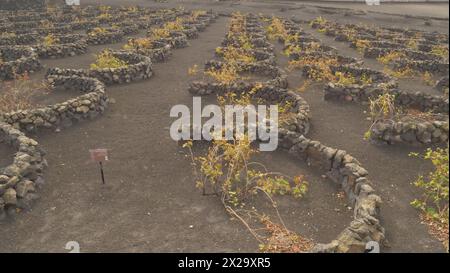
top-left (0, 0), bottom-right (448, 252)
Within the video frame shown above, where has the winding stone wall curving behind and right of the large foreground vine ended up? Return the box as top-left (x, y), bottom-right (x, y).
top-left (190, 15), bottom-right (385, 252)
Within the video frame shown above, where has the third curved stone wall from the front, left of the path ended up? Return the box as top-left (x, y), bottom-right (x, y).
top-left (47, 51), bottom-right (153, 85)
